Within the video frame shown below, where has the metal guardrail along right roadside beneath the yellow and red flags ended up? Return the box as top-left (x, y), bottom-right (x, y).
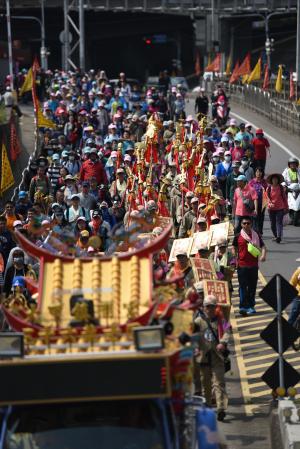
top-left (226, 84), bottom-right (300, 135)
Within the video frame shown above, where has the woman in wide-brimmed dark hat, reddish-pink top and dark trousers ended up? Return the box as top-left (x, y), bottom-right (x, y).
top-left (266, 173), bottom-right (288, 243)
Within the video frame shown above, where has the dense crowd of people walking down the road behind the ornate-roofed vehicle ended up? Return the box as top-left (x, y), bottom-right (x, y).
top-left (0, 70), bottom-right (300, 420)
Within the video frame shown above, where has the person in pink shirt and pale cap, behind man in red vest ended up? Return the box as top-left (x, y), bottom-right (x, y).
top-left (233, 175), bottom-right (258, 234)
